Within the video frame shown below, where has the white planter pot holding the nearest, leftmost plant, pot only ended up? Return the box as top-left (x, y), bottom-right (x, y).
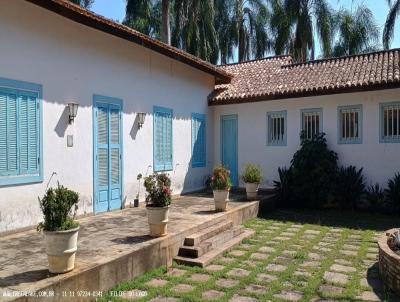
top-left (43, 227), bottom-right (79, 274)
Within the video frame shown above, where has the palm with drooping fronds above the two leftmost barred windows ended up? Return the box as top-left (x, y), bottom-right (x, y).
top-left (271, 0), bottom-right (334, 62)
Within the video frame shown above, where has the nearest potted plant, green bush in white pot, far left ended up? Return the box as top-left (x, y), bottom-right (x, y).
top-left (37, 184), bottom-right (79, 274)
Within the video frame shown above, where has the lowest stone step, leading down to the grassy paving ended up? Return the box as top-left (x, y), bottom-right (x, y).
top-left (174, 229), bottom-right (254, 267)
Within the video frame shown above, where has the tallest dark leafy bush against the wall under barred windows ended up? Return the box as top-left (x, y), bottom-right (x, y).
top-left (290, 133), bottom-right (338, 208)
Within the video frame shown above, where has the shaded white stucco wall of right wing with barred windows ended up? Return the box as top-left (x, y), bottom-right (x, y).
top-left (213, 89), bottom-right (400, 186)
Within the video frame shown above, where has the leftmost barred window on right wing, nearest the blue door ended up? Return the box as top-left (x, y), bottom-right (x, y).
top-left (267, 110), bottom-right (287, 146)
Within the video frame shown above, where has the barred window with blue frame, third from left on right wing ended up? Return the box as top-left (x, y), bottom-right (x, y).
top-left (338, 105), bottom-right (362, 144)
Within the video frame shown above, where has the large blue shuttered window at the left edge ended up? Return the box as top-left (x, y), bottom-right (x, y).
top-left (0, 78), bottom-right (42, 185)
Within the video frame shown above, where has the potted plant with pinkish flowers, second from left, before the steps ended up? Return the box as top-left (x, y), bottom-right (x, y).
top-left (144, 173), bottom-right (172, 237)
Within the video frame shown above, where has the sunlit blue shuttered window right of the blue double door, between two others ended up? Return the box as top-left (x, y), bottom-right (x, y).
top-left (153, 107), bottom-right (173, 172)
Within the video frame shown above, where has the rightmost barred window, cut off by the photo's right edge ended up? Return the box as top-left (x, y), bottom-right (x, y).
top-left (380, 102), bottom-right (400, 143)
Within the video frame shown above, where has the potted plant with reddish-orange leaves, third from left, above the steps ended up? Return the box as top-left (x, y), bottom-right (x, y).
top-left (211, 166), bottom-right (232, 211)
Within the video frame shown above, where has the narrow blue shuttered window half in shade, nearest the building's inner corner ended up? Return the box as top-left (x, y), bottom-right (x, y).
top-left (192, 113), bottom-right (206, 168)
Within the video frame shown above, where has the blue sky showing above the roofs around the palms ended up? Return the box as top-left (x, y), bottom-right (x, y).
top-left (92, 0), bottom-right (400, 56)
